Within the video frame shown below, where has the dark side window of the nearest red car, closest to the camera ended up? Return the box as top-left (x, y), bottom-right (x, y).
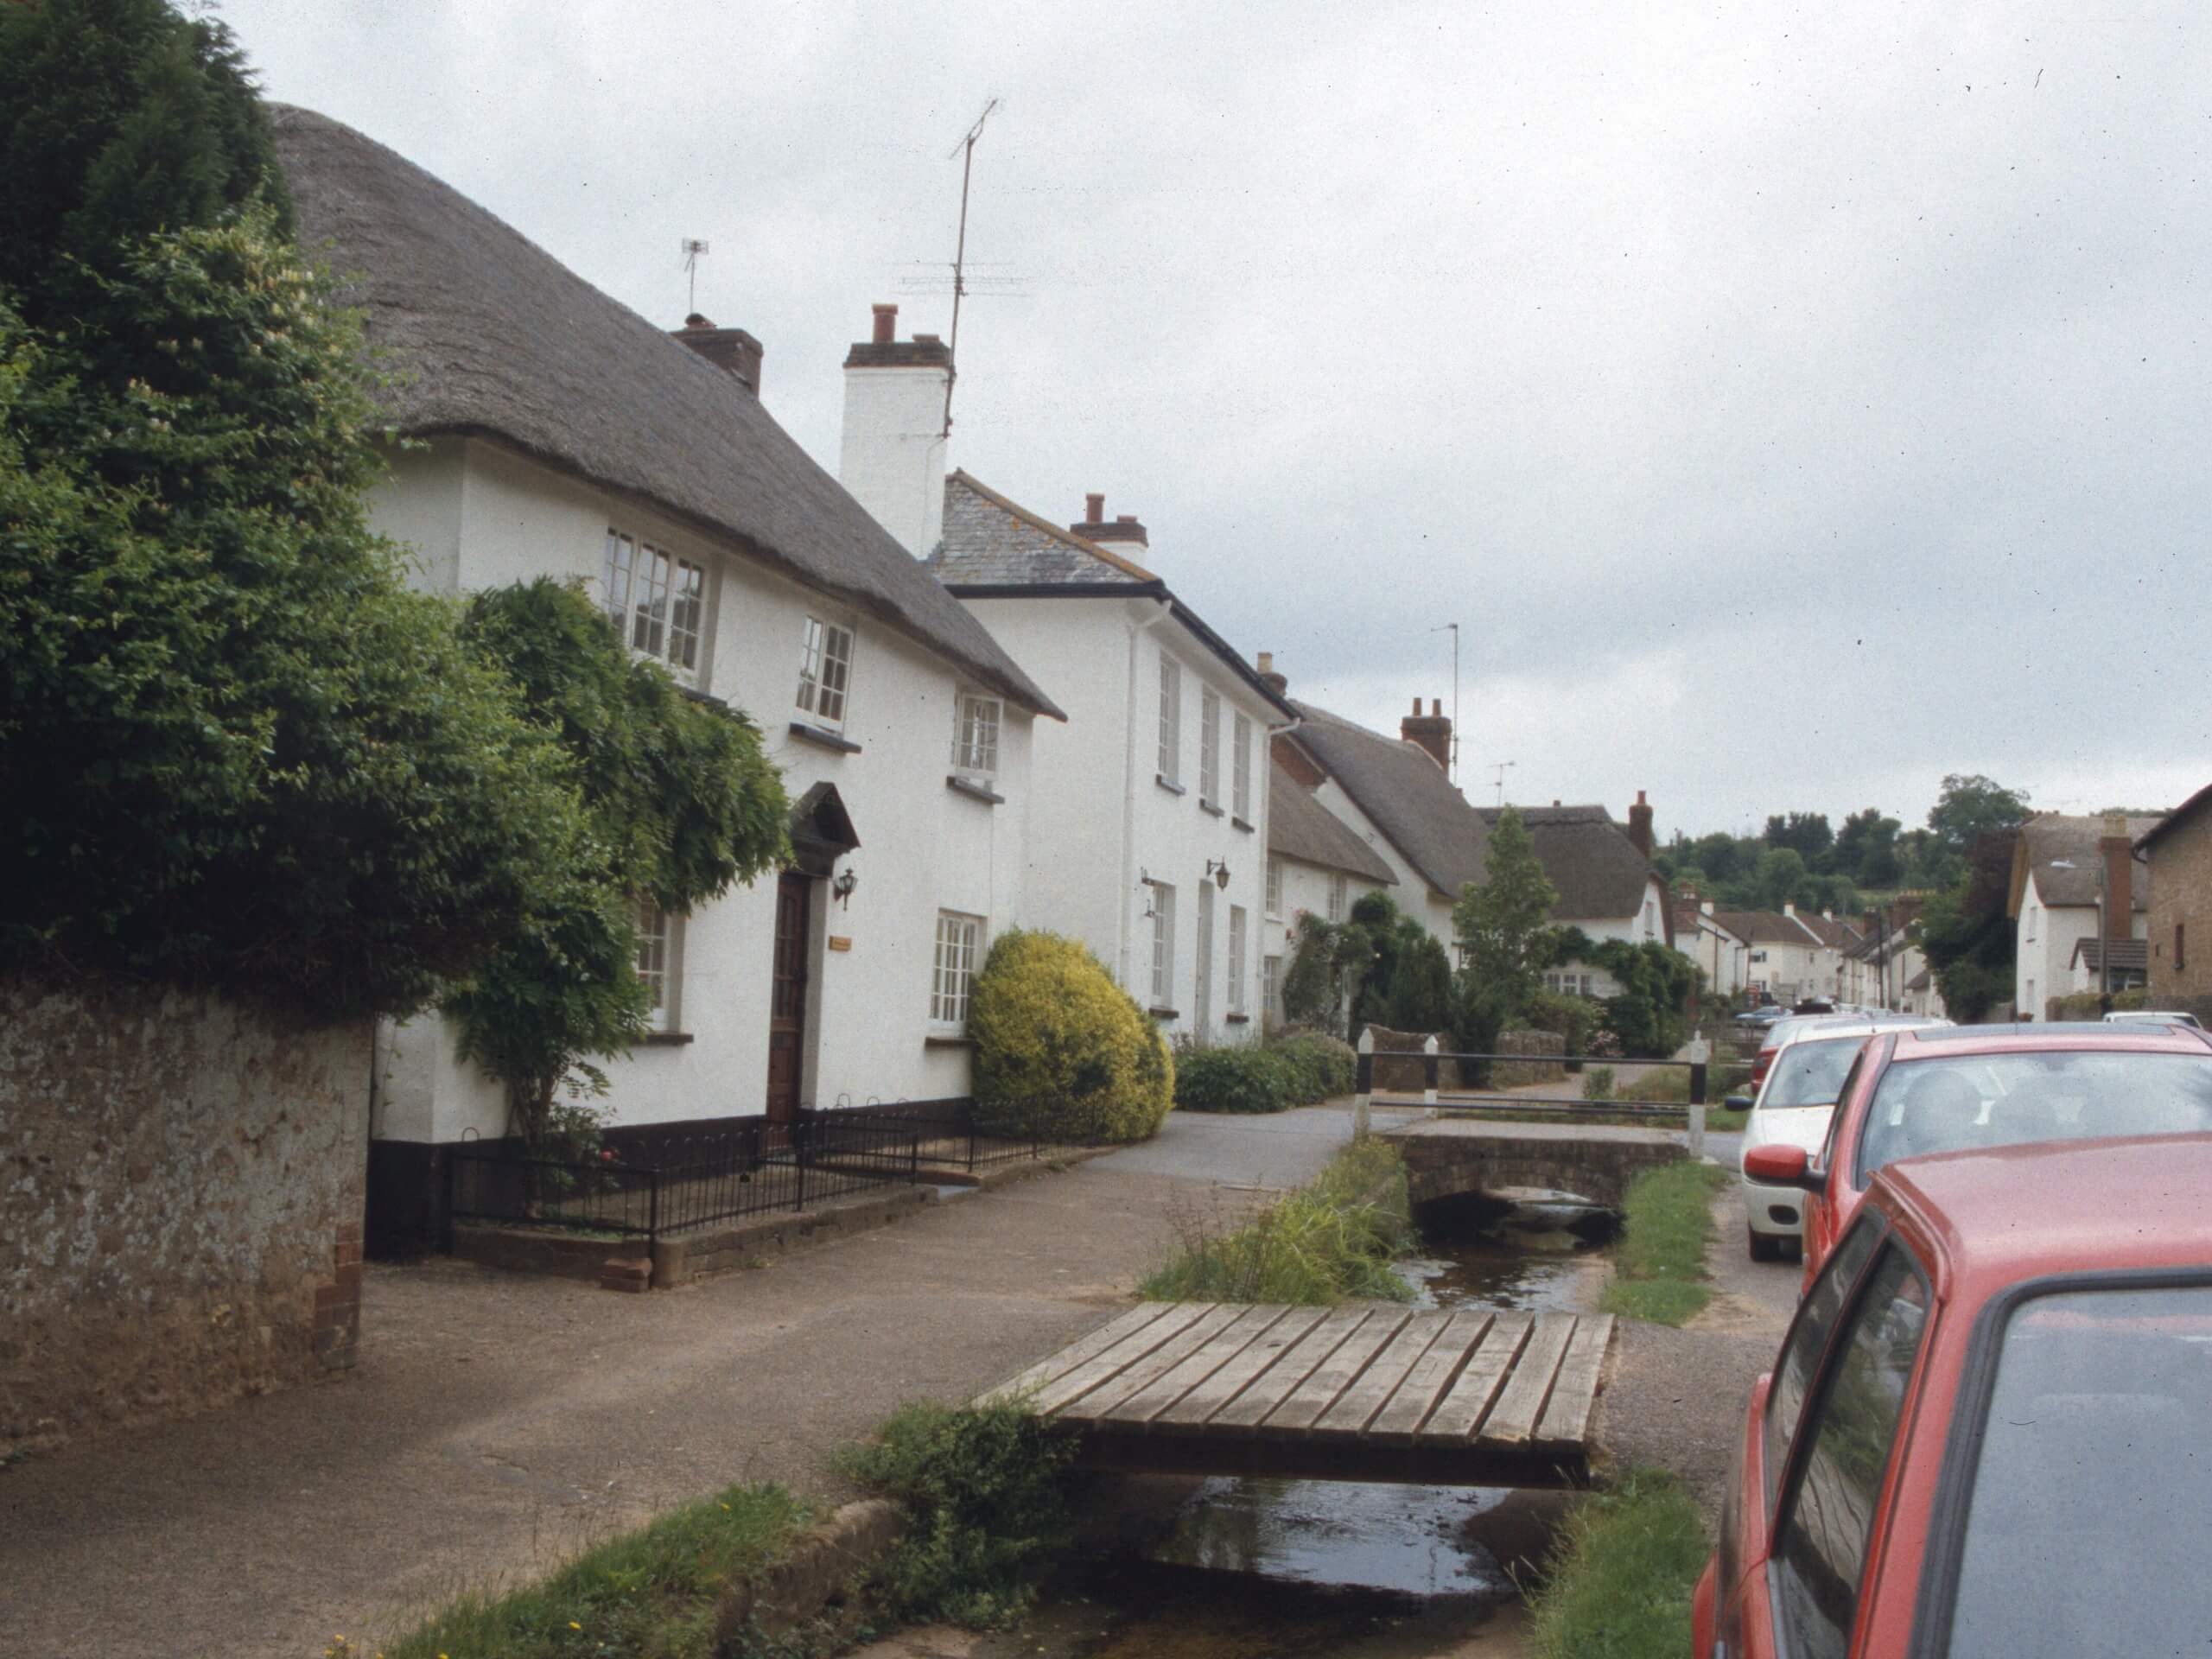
top-left (1774, 1245), bottom-right (1927, 1659)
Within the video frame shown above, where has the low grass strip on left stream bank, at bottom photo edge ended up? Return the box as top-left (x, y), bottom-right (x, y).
top-left (376, 1484), bottom-right (814, 1659)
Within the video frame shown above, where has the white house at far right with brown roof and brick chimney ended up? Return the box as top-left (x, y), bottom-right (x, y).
top-left (2006, 812), bottom-right (2159, 1020)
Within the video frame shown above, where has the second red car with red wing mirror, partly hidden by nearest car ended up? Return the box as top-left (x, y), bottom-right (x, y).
top-left (1743, 1024), bottom-right (2212, 1285)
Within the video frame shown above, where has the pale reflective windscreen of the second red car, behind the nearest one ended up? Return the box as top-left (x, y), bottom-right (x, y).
top-left (1853, 1048), bottom-right (2212, 1185)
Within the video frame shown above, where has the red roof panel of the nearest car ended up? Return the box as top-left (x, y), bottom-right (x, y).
top-left (1867, 1135), bottom-right (2212, 1300)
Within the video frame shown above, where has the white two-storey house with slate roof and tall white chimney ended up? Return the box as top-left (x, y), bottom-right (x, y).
top-left (838, 329), bottom-right (1294, 1044)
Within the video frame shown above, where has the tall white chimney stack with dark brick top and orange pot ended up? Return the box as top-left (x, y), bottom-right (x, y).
top-left (836, 305), bottom-right (953, 560)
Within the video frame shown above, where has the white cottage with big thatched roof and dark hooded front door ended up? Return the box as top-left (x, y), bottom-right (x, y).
top-left (276, 108), bottom-right (1059, 1238)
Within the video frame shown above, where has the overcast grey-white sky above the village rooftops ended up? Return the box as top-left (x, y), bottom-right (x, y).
top-left (221, 0), bottom-right (2212, 834)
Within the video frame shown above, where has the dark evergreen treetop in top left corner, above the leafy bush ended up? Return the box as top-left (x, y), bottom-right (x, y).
top-left (0, 0), bottom-right (292, 329)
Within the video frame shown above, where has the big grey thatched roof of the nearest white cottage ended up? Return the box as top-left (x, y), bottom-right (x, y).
top-left (270, 104), bottom-right (1064, 719)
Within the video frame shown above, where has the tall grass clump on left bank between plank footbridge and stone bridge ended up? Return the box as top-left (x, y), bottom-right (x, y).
top-left (1137, 1137), bottom-right (1415, 1307)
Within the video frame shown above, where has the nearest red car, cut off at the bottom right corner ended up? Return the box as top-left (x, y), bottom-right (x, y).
top-left (1690, 1135), bottom-right (2212, 1659)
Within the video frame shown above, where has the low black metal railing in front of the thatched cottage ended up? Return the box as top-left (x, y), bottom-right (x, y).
top-left (445, 1102), bottom-right (1048, 1245)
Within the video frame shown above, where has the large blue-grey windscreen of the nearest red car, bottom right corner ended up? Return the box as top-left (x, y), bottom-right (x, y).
top-left (1948, 1285), bottom-right (2212, 1659)
